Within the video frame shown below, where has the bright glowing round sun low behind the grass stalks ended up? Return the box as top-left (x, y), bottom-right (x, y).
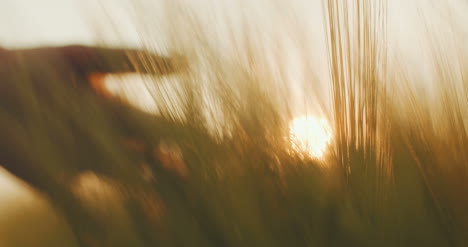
top-left (289, 116), bottom-right (332, 158)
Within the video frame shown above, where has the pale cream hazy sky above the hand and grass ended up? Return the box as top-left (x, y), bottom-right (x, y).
top-left (0, 0), bottom-right (468, 119)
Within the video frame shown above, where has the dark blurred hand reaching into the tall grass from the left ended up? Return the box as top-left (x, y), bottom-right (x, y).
top-left (0, 43), bottom-right (188, 244)
